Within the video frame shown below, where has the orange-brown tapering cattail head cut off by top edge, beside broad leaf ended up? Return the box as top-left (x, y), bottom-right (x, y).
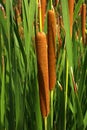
top-left (68, 0), bottom-right (74, 37)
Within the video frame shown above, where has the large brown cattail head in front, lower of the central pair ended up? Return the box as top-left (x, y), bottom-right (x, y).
top-left (36, 32), bottom-right (49, 117)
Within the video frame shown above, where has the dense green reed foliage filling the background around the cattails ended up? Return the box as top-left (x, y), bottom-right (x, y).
top-left (0, 0), bottom-right (87, 130)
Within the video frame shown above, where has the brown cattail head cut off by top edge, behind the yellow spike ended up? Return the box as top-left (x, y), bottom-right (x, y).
top-left (41, 0), bottom-right (47, 29)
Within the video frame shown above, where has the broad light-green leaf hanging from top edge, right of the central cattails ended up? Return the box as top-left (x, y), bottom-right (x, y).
top-left (61, 0), bottom-right (73, 66)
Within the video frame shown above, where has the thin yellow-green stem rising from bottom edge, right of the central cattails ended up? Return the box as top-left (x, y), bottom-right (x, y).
top-left (64, 58), bottom-right (68, 130)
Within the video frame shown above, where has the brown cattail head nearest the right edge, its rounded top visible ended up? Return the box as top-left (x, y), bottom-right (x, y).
top-left (81, 4), bottom-right (86, 43)
